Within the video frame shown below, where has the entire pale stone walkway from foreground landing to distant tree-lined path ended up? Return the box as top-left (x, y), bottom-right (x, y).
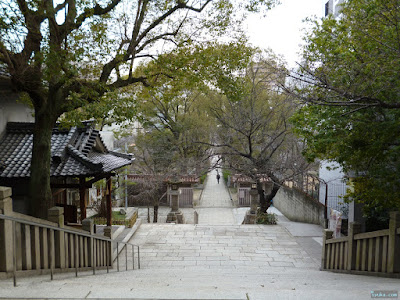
top-left (0, 171), bottom-right (400, 300)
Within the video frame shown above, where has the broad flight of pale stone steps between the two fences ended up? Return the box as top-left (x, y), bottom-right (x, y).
top-left (128, 224), bottom-right (318, 270)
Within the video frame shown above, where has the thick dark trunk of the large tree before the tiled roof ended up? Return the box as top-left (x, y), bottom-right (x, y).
top-left (29, 108), bottom-right (57, 219)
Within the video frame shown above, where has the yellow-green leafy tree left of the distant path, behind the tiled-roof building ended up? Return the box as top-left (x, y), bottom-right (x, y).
top-left (114, 40), bottom-right (253, 220)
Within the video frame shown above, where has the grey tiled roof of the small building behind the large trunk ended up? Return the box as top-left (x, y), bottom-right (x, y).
top-left (0, 122), bottom-right (132, 178)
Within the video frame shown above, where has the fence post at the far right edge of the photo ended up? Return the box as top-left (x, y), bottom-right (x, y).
top-left (388, 211), bottom-right (400, 273)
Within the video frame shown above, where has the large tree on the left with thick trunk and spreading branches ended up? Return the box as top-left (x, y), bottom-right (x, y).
top-left (0, 0), bottom-right (275, 217)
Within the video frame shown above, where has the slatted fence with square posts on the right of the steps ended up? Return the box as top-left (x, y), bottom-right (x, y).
top-left (321, 212), bottom-right (400, 278)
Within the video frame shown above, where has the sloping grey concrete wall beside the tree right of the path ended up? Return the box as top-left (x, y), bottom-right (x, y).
top-left (273, 187), bottom-right (324, 225)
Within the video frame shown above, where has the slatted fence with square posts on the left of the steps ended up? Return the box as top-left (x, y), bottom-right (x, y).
top-left (0, 187), bottom-right (139, 286)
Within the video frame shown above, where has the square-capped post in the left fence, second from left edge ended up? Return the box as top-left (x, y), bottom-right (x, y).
top-left (47, 206), bottom-right (65, 269)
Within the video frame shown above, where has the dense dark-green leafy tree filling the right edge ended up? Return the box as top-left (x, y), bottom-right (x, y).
top-left (286, 0), bottom-right (400, 224)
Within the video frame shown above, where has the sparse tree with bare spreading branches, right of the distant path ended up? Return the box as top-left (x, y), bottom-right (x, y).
top-left (210, 54), bottom-right (308, 213)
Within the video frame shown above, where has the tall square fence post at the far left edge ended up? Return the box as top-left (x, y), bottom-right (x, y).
top-left (0, 186), bottom-right (13, 272)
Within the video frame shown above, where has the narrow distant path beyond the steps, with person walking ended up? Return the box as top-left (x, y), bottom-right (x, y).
top-left (195, 170), bottom-right (235, 225)
